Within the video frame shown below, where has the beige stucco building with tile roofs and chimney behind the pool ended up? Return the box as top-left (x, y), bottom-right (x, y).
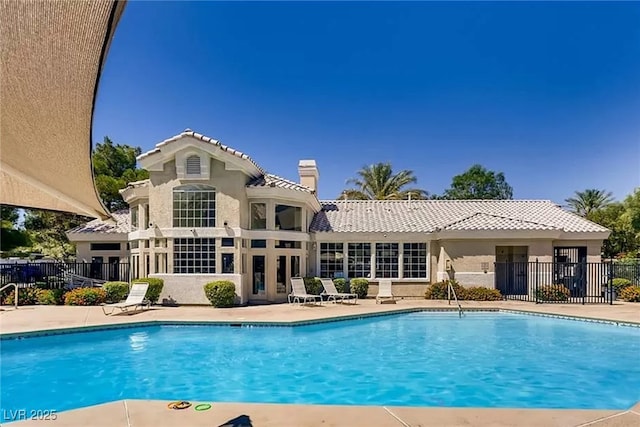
top-left (68, 130), bottom-right (609, 304)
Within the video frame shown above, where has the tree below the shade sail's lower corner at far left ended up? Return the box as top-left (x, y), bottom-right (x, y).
top-left (24, 209), bottom-right (88, 259)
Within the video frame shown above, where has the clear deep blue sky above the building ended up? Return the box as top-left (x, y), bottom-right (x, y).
top-left (93, 1), bottom-right (640, 203)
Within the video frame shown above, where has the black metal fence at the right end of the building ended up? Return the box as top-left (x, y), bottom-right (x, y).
top-left (495, 261), bottom-right (640, 304)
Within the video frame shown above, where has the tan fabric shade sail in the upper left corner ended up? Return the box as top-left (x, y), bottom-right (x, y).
top-left (0, 0), bottom-right (125, 218)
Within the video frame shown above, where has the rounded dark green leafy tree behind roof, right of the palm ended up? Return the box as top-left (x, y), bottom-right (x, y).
top-left (435, 165), bottom-right (513, 200)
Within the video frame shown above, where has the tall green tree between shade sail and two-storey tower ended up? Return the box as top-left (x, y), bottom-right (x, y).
top-left (93, 136), bottom-right (149, 211)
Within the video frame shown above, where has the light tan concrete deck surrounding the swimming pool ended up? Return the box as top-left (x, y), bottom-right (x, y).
top-left (0, 300), bottom-right (640, 427)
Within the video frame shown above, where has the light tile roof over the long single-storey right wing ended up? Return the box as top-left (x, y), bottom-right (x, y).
top-left (310, 200), bottom-right (608, 233)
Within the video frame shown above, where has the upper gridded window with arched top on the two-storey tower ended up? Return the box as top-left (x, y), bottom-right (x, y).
top-left (173, 185), bottom-right (216, 227)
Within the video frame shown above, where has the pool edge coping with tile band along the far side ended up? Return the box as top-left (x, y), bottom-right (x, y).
top-left (0, 307), bottom-right (640, 341)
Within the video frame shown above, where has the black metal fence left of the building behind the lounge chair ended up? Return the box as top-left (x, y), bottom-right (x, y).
top-left (0, 261), bottom-right (131, 289)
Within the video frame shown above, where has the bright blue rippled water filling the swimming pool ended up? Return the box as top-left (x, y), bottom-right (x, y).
top-left (0, 313), bottom-right (640, 413)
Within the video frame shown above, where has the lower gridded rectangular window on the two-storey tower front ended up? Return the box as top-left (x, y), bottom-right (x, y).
top-left (173, 238), bottom-right (216, 274)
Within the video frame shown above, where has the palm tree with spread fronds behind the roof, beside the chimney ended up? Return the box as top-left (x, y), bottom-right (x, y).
top-left (339, 163), bottom-right (428, 200)
